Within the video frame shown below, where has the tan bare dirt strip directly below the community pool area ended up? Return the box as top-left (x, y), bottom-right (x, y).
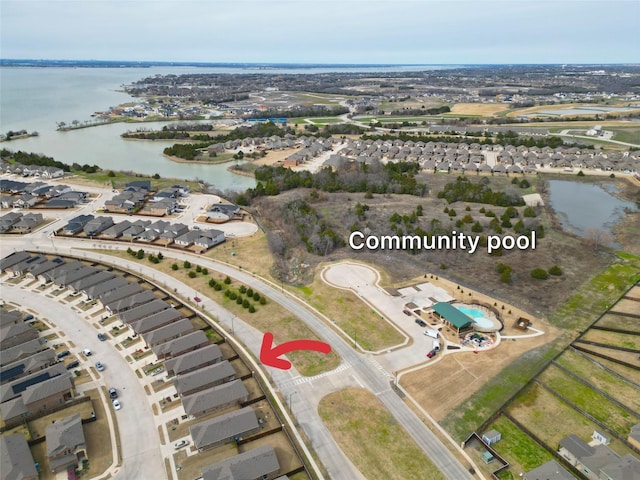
top-left (400, 316), bottom-right (558, 421)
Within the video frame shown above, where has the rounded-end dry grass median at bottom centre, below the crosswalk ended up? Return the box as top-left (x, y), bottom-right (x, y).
top-left (318, 388), bottom-right (445, 480)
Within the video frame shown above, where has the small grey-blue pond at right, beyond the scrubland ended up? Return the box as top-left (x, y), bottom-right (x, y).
top-left (549, 180), bottom-right (636, 236)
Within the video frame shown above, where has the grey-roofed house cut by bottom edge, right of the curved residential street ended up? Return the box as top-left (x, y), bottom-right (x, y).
top-left (201, 445), bottom-right (280, 480)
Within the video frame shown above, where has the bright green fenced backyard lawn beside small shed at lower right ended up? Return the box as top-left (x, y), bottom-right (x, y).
top-left (490, 416), bottom-right (553, 472)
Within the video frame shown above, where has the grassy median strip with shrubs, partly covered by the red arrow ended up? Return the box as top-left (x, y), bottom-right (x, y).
top-left (103, 251), bottom-right (340, 376)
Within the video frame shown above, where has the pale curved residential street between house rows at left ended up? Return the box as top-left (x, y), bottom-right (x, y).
top-left (0, 284), bottom-right (166, 480)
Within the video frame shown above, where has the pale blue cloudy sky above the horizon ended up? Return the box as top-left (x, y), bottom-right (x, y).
top-left (0, 0), bottom-right (640, 64)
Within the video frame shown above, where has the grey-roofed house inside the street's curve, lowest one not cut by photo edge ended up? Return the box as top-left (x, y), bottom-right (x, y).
top-left (45, 413), bottom-right (89, 473)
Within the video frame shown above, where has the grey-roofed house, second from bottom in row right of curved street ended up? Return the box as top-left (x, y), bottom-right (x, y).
top-left (189, 407), bottom-right (260, 452)
